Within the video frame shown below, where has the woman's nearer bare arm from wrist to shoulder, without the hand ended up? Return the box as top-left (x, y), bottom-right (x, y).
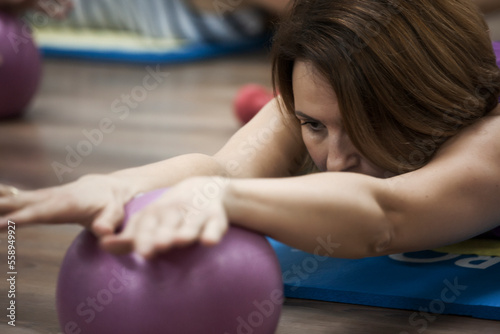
top-left (222, 112), bottom-right (500, 258)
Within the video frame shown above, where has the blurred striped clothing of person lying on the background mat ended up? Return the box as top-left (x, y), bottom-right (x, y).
top-left (25, 0), bottom-right (267, 44)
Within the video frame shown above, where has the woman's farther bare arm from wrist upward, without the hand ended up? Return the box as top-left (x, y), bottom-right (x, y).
top-left (110, 96), bottom-right (306, 194)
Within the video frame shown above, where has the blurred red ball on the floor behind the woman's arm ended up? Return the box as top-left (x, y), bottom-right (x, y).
top-left (234, 84), bottom-right (274, 124)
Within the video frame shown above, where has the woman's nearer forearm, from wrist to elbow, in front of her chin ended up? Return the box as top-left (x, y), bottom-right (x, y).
top-left (225, 173), bottom-right (390, 258)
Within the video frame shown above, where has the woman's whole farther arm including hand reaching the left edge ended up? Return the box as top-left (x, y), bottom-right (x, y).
top-left (0, 102), bottom-right (305, 236)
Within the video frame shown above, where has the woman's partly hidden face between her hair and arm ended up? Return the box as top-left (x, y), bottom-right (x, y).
top-left (293, 62), bottom-right (386, 177)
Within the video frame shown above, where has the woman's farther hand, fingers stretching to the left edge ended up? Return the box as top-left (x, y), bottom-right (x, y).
top-left (0, 175), bottom-right (134, 237)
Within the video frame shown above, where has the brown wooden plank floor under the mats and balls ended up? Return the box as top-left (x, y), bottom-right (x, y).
top-left (0, 52), bottom-right (500, 334)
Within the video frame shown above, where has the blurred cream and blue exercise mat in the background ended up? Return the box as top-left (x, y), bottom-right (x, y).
top-left (33, 28), bottom-right (269, 64)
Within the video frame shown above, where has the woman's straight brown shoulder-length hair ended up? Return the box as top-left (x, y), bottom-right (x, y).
top-left (272, 0), bottom-right (500, 174)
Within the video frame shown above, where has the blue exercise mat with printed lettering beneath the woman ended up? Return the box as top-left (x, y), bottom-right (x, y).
top-left (269, 239), bottom-right (500, 320)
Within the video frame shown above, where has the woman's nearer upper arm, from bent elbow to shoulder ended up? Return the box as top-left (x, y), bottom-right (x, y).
top-left (379, 107), bottom-right (500, 248)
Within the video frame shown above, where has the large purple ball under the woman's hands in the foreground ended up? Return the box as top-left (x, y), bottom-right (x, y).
top-left (56, 190), bottom-right (283, 334)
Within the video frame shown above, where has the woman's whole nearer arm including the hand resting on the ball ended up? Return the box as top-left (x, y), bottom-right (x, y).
top-left (103, 108), bottom-right (500, 258)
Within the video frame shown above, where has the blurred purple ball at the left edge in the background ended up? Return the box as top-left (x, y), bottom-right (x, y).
top-left (0, 12), bottom-right (41, 119)
